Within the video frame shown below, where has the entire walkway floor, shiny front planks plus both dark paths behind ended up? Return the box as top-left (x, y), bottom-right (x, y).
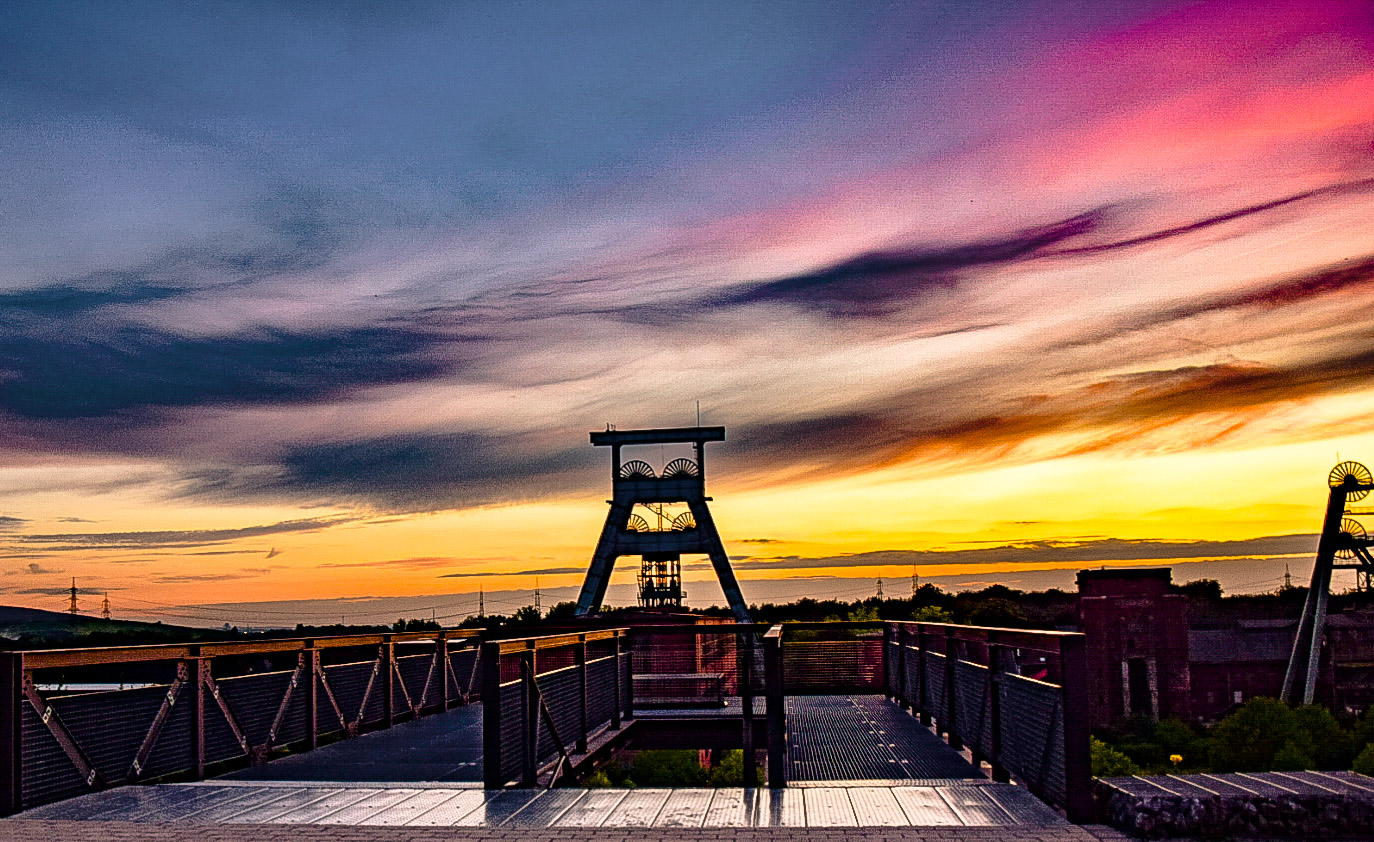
top-left (10, 696), bottom-right (1065, 830)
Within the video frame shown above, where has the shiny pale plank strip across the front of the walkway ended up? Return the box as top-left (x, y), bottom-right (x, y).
top-left (16, 780), bottom-right (1065, 830)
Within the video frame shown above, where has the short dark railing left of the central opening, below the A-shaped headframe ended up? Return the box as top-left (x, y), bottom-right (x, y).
top-left (482, 629), bottom-right (632, 788)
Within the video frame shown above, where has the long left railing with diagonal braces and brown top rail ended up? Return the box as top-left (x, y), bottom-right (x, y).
top-left (0, 630), bottom-right (481, 815)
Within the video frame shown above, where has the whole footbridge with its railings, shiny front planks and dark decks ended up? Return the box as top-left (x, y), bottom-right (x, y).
top-left (0, 622), bottom-right (1091, 830)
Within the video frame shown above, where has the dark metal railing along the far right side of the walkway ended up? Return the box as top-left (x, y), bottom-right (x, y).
top-left (883, 622), bottom-right (1092, 821)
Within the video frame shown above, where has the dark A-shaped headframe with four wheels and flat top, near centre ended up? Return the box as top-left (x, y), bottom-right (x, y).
top-left (576, 427), bottom-right (752, 622)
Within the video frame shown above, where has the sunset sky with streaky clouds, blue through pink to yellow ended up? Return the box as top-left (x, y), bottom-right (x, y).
top-left (0, 0), bottom-right (1374, 622)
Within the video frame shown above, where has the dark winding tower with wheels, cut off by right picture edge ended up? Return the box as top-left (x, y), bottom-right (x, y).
top-left (1282, 462), bottom-right (1374, 705)
